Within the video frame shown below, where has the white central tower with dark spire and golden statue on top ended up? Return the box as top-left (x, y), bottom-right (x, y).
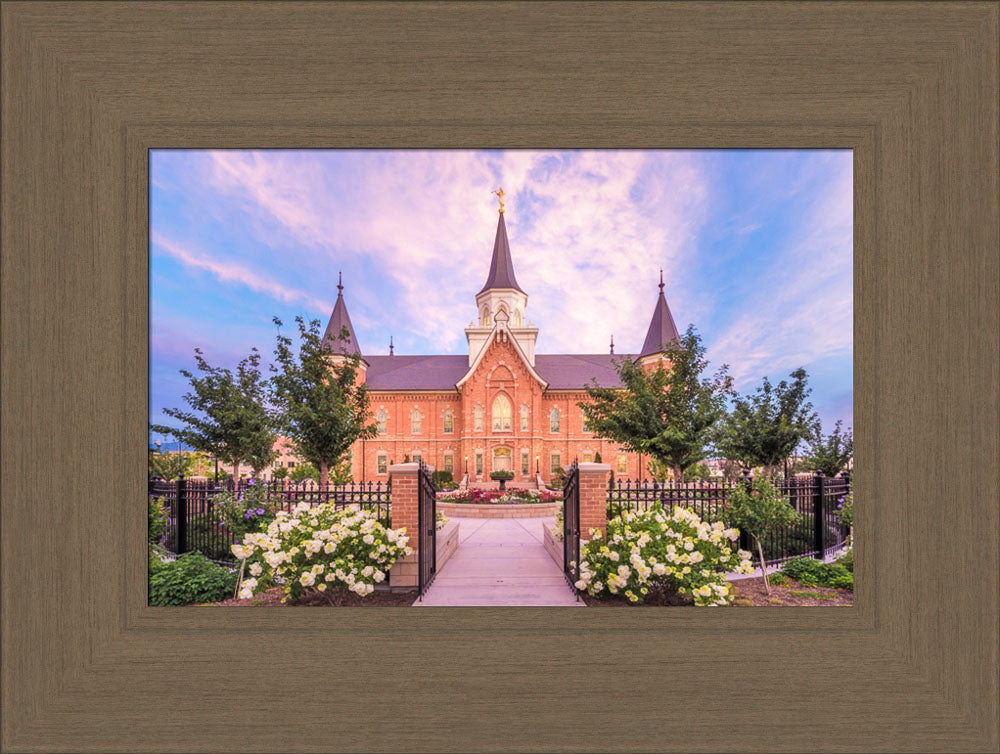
top-left (465, 188), bottom-right (538, 366)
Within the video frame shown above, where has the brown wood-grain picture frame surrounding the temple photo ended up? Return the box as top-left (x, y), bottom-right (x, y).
top-left (0, 2), bottom-right (1000, 752)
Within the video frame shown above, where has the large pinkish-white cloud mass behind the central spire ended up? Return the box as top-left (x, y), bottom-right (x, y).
top-left (201, 151), bottom-right (708, 353)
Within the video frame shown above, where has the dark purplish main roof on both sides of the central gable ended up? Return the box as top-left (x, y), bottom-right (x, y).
top-left (365, 353), bottom-right (622, 390)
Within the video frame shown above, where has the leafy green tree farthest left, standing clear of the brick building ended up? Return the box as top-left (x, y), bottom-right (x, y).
top-left (152, 348), bottom-right (276, 477)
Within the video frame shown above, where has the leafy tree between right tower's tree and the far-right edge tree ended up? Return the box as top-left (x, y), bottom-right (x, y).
top-left (716, 368), bottom-right (817, 476)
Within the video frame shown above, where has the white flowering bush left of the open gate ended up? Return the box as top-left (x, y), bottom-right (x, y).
top-left (232, 503), bottom-right (413, 602)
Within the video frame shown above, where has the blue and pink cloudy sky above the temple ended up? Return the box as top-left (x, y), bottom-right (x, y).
top-left (149, 150), bottom-right (853, 444)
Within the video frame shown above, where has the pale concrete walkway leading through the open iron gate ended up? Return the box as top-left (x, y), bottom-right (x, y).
top-left (414, 518), bottom-right (584, 607)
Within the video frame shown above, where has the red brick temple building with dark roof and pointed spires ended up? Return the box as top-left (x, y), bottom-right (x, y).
top-left (324, 203), bottom-right (678, 487)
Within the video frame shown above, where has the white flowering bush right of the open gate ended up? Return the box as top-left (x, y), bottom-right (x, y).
top-left (576, 505), bottom-right (753, 605)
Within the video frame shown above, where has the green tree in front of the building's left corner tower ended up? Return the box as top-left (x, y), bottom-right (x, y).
top-left (271, 317), bottom-right (376, 485)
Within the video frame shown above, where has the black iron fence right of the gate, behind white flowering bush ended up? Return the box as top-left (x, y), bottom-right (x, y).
top-left (608, 474), bottom-right (851, 563)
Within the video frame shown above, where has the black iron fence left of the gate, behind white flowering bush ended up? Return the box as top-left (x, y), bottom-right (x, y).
top-left (149, 477), bottom-right (391, 561)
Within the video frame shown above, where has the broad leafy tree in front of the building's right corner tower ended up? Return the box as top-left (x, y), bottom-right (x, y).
top-left (577, 327), bottom-right (732, 479)
